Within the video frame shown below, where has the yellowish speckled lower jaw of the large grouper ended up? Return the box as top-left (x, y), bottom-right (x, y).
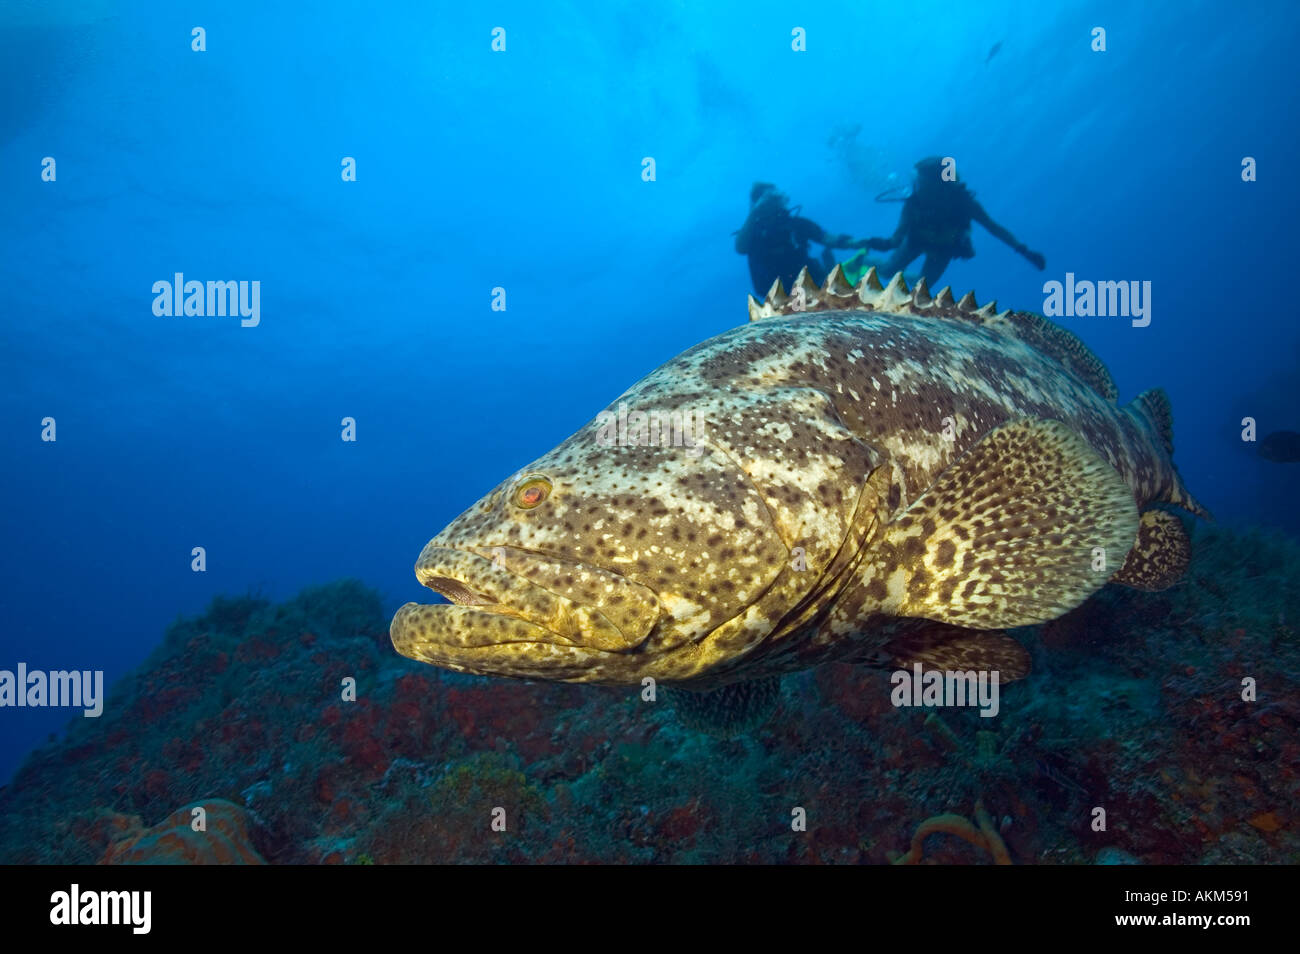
top-left (389, 603), bottom-right (624, 682)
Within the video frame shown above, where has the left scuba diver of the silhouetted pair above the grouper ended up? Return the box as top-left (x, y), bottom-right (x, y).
top-left (732, 182), bottom-right (862, 296)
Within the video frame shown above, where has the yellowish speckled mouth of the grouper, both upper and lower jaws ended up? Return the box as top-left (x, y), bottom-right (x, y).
top-left (389, 542), bottom-right (660, 681)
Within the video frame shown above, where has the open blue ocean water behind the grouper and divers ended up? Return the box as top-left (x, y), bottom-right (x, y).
top-left (0, 0), bottom-right (1300, 779)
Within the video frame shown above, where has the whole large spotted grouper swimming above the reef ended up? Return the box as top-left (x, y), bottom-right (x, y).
top-left (391, 269), bottom-right (1208, 689)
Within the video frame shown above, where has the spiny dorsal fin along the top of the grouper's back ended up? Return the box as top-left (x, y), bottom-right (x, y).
top-left (749, 265), bottom-right (1119, 400)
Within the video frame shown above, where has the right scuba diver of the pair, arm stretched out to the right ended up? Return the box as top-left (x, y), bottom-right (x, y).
top-left (859, 156), bottom-right (1047, 287)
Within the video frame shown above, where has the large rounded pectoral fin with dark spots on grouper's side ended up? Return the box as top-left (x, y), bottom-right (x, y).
top-left (865, 419), bottom-right (1138, 629)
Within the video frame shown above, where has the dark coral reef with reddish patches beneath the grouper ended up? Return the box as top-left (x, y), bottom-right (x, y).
top-left (0, 528), bottom-right (1300, 864)
